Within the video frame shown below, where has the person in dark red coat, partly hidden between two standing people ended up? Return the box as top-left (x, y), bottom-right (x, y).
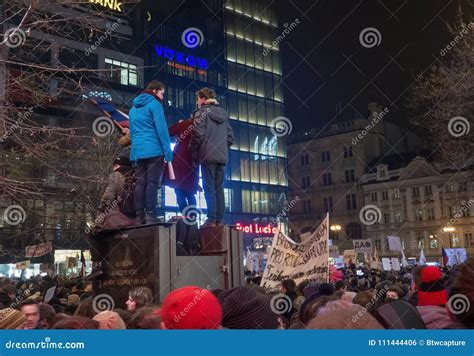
top-left (163, 119), bottom-right (201, 214)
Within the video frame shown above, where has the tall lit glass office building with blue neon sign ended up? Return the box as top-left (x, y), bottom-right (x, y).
top-left (135, 0), bottom-right (288, 225)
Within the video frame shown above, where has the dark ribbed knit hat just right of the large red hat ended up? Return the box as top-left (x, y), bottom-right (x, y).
top-left (219, 287), bottom-right (278, 329)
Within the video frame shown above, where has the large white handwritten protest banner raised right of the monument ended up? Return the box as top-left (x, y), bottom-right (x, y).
top-left (260, 215), bottom-right (329, 289)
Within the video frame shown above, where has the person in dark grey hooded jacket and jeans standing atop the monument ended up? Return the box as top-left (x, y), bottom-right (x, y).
top-left (189, 88), bottom-right (234, 227)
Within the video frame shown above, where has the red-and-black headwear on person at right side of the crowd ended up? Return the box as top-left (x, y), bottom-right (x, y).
top-left (418, 266), bottom-right (448, 306)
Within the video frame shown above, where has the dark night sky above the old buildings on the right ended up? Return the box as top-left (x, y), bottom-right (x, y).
top-left (278, 0), bottom-right (474, 132)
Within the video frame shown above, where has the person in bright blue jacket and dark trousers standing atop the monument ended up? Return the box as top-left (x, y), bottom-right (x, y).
top-left (129, 81), bottom-right (173, 224)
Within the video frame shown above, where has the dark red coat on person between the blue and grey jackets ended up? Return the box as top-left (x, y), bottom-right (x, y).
top-left (163, 119), bottom-right (199, 193)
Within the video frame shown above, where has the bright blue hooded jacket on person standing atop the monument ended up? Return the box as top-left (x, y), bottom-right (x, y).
top-left (129, 93), bottom-right (173, 162)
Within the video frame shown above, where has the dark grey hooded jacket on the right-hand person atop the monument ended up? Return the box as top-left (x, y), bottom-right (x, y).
top-left (189, 101), bottom-right (234, 164)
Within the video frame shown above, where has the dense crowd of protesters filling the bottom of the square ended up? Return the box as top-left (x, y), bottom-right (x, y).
top-left (0, 260), bottom-right (474, 329)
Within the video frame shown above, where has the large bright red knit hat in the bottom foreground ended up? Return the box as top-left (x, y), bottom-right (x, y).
top-left (161, 286), bottom-right (222, 329)
